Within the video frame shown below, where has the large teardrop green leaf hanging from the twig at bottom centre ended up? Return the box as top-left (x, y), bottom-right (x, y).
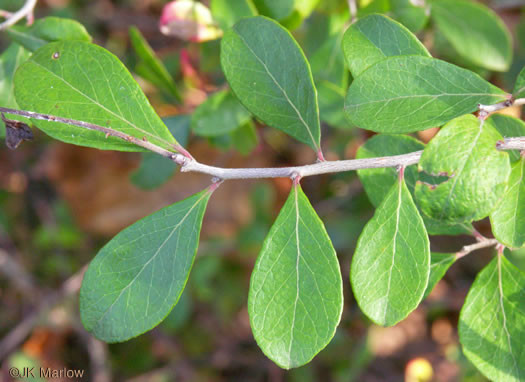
top-left (248, 185), bottom-right (343, 369)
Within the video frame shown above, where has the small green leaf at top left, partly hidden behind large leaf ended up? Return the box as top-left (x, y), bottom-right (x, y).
top-left (7, 17), bottom-right (91, 52)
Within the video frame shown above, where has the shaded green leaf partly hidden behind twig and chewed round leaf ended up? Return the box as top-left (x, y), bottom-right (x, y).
top-left (356, 134), bottom-right (472, 235)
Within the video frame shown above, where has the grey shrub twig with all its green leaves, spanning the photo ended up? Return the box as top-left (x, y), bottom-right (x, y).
top-left (0, 0), bottom-right (525, 381)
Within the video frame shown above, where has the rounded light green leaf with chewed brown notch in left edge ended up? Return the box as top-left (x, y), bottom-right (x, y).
top-left (416, 114), bottom-right (510, 223)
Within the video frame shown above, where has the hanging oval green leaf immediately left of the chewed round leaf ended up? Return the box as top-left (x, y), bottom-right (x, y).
top-left (350, 173), bottom-right (430, 326)
